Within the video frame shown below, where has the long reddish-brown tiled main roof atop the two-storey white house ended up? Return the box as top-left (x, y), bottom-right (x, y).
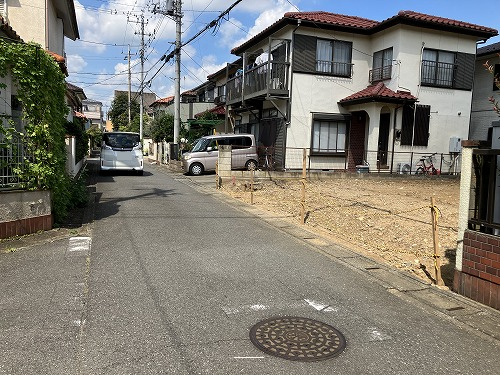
top-left (231, 10), bottom-right (498, 55)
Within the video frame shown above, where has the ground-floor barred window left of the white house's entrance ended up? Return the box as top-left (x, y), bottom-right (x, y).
top-left (311, 119), bottom-right (347, 154)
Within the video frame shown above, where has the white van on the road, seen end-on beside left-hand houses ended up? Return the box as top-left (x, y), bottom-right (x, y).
top-left (99, 132), bottom-right (144, 175)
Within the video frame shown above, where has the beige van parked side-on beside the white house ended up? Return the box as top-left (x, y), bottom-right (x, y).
top-left (183, 134), bottom-right (259, 175)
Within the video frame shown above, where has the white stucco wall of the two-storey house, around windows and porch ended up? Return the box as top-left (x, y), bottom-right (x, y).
top-left (287, 26), bottom-right (476, 168)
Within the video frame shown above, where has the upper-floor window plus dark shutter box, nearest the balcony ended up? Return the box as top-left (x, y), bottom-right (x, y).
top-left (293, 34), bottom-right (352, 77)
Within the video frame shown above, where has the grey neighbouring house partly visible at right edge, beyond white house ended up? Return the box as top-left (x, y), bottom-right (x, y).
top-left (469, 42), bottom-right (500, 141)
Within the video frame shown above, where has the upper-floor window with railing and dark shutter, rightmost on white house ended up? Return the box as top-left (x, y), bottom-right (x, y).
top-left (421, 49), bottom-right (475, 90)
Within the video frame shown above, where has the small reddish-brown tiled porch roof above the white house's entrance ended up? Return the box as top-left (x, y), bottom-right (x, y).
top-left (339, 82), bottom-right (417, 105)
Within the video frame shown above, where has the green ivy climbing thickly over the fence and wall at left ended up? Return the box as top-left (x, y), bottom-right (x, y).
top-left (0, 40), bottom-right (84, 222)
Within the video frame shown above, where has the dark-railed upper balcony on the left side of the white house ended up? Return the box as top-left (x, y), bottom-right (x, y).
top-left (226, 61), bottom-right (289, 105)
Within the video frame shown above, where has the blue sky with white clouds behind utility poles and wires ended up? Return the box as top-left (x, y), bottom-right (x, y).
top-left (66, 0), bottom-right (500, 112)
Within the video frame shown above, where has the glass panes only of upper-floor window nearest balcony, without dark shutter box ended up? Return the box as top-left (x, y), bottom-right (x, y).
top-left (316, 39), bottom-right (351, 77)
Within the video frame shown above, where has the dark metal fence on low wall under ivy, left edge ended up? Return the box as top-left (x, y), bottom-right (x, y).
top-left (0, 133), bottom-right (29, 190)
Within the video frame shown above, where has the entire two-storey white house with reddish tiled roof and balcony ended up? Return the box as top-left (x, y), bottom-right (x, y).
top-left (225, 11), bottom-right (498, 171)
